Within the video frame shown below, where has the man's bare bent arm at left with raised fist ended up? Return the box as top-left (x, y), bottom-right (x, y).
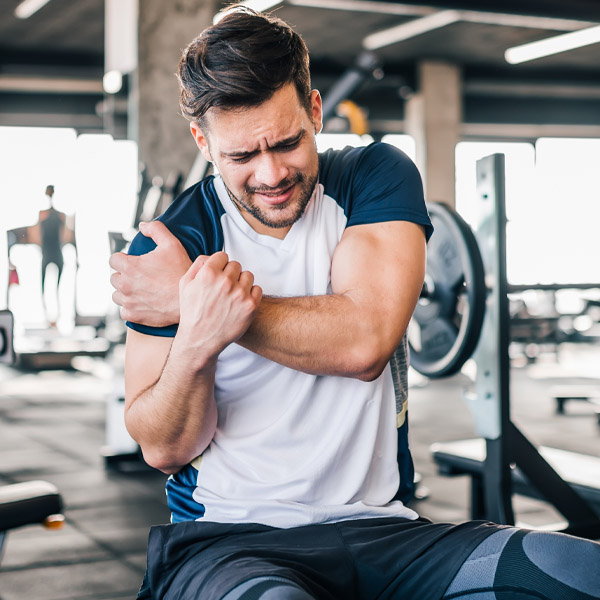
top-left (125, 252), bottom-right (261, 473)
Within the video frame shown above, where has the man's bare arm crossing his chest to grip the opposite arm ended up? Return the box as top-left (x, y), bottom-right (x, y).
top-left (111, 221), bottom-right (425, 380)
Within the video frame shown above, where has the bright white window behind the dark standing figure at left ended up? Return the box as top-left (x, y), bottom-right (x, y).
top-left (0, 127), bottom-right (138, 331)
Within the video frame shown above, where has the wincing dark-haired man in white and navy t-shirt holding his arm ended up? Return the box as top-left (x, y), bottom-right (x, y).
top-left (111, 9), bottom-right (600, 600)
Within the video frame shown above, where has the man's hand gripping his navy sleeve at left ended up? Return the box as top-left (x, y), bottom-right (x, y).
top-left (109, 221), bottom-right (190, 327)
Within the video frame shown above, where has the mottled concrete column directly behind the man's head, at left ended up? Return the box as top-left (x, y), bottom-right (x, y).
top-left (135, 0), bottom-right (217, 180)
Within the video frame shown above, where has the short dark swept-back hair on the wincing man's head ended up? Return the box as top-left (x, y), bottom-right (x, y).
top-left (177, 7), bottom-right (311, 125)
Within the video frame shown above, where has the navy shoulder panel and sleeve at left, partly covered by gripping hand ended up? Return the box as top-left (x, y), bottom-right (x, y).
top-left (126, 176), bottom-right (225, 337)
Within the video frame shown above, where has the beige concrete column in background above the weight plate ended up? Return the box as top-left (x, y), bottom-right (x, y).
top-left (405, 61), bottom-right (462, 207)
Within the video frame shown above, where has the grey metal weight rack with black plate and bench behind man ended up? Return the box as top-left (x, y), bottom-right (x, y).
top-left (409, 154), bottom-right (600, 539)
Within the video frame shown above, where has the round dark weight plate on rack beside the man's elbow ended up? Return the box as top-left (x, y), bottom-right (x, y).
top-left (408, 202), bottom-right (486, 378)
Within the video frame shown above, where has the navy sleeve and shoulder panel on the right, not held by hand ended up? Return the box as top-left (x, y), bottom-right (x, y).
top-left (319, 142), bottom-right (433, 239)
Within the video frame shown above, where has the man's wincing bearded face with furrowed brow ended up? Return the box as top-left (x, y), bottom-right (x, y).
top-left (191, 84), bottom-right (322, 238)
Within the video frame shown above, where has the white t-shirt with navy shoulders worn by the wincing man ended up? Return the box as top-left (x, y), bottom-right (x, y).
top-left (130, 144), bottom-right (428, 527)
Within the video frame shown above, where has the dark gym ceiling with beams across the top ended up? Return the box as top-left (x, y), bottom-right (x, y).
top-left (0, 0), bottom-right (600, 131)
